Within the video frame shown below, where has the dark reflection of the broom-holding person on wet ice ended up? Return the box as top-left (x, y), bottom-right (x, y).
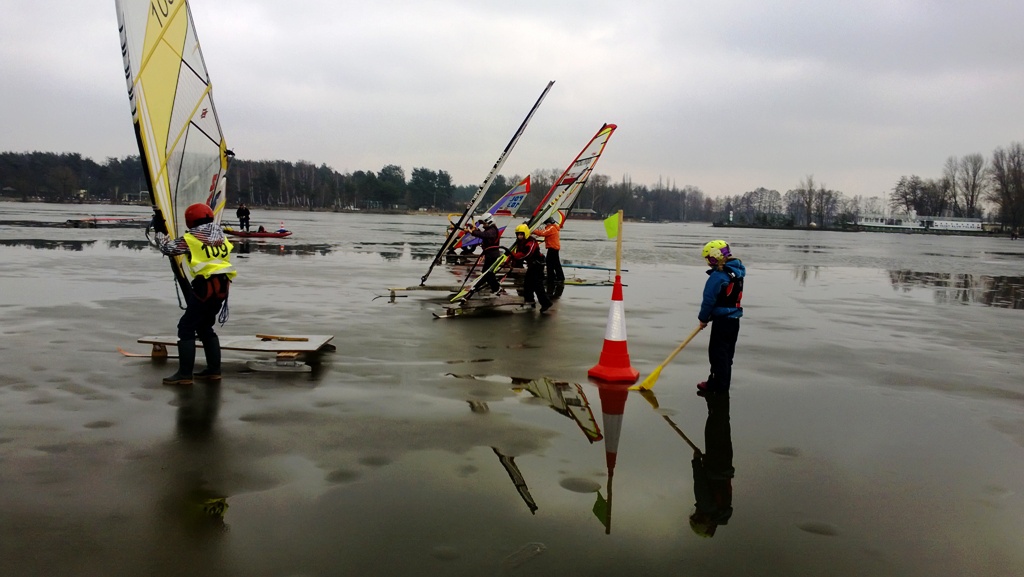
top-left (690, 391), bottom-right (735, 537)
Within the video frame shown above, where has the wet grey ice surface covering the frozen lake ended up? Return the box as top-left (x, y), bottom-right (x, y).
top-left (0, 203), bottom-right (1024, 576)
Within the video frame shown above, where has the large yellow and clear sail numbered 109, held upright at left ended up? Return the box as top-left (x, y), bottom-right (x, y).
top-left (115, 0), bottom-right (232, 294)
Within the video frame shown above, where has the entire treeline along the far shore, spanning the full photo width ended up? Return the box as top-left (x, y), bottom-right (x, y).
top-left (0, 138), bottom-right (1024, 230)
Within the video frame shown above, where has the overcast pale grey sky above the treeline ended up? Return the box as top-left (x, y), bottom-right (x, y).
top-left (0, 0), bottom-right (1024, 197)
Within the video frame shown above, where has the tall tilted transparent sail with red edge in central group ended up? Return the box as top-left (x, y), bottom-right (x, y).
top-left (452, 124), bottom-right (617, 302)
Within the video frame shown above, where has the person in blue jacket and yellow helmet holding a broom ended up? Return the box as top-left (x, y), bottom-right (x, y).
top-left (697, 241), bottom-right (746, 397)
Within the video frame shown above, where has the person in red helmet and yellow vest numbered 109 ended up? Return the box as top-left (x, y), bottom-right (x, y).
top-left (157, 204), bottom-right (238, 384)
